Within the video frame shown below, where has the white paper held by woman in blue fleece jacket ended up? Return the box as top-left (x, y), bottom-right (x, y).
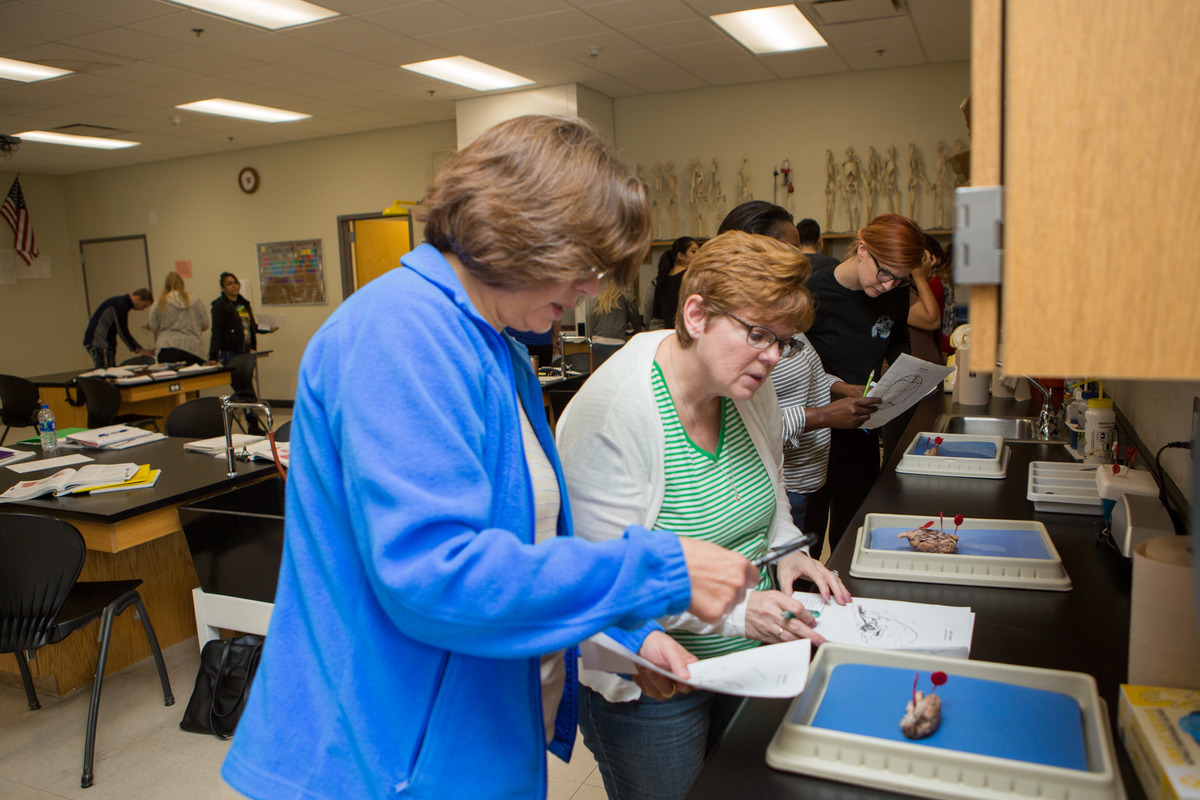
top-left (580, 633), bottom-right (811, 697)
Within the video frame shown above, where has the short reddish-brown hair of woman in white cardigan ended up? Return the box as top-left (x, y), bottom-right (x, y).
top-left (676, 230), bottom-right (815, 348)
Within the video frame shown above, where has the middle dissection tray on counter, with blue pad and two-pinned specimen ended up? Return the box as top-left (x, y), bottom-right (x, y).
top-left (850, 513), bottom-right (1070, 591)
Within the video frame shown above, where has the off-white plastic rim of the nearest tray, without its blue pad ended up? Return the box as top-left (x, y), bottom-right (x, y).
top-left (767, 644), bottom-right (1126, 800)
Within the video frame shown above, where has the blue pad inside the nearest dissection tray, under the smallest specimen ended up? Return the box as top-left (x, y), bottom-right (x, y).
top-left (806, 664), bottom-right (1087, 770)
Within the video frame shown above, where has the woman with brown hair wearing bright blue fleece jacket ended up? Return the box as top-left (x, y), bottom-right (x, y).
top-left (222, 116), bottom-right (758, 800)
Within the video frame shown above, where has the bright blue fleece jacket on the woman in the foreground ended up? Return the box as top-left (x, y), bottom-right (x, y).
top-left (222, 245), bottom-right (690, 800)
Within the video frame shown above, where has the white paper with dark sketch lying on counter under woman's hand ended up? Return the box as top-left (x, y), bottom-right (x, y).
top-left (792, 591), bottom-right (974, 658)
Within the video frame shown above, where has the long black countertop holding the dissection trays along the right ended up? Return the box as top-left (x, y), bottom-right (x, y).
top-left (686, 395), bottom-right (1145, 800)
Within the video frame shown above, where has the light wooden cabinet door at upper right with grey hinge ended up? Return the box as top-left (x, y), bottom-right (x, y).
top-left (973, 0), bottom-right (1200, 379)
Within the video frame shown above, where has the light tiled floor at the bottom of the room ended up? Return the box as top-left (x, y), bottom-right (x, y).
top-left (0, 634), bottom-right (606, 800)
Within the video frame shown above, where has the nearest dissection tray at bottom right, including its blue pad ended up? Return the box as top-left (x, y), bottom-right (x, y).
top-left (767, 644), bottom-right (1126, 800)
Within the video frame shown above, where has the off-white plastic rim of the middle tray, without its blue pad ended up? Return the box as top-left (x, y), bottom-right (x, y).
top-left (850, 513), bottom-right (1070, 591)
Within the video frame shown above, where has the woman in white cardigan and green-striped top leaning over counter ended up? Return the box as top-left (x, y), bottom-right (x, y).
top-left (558, 231), bottom-right (851, 800)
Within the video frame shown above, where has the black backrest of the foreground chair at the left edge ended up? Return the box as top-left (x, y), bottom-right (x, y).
top-left (0, 513), bottom-right (86, 652)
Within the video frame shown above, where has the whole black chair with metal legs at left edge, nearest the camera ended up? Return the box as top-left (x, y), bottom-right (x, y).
top-left (0, 513), bottom-right (175, 788)
